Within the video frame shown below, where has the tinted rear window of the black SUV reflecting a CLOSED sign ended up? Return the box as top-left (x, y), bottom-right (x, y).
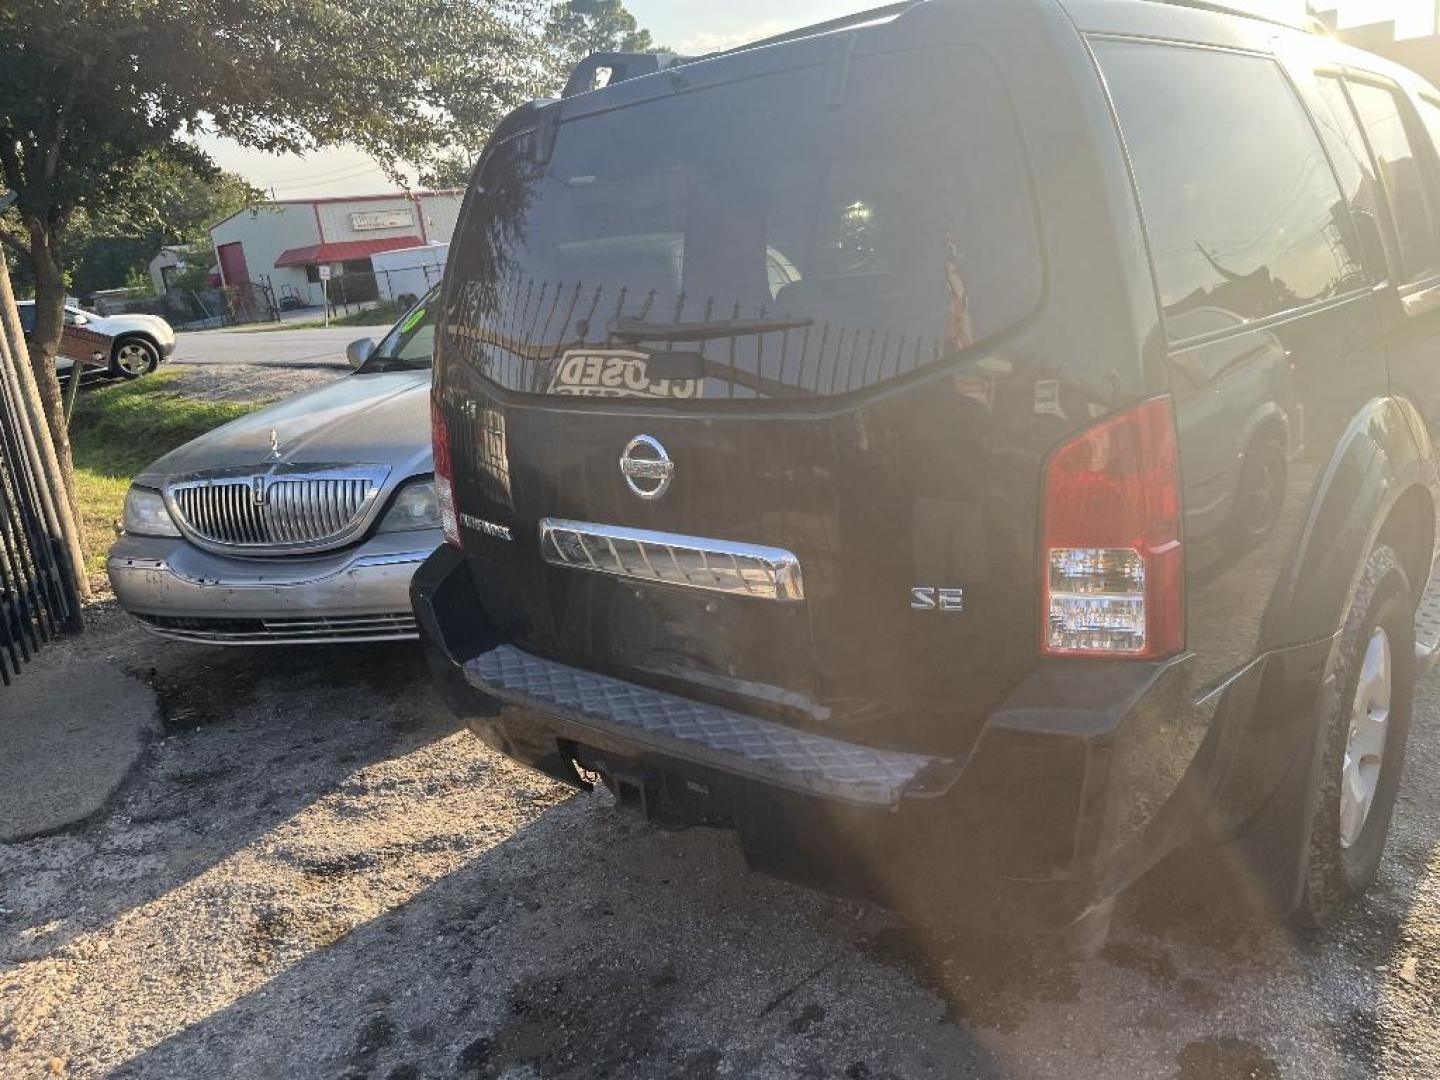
top-left (442, 49), bottom-right (1041, 397)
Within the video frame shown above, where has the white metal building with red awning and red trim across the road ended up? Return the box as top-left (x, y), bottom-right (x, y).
top-left (210, 189), bottom-right (464, 307)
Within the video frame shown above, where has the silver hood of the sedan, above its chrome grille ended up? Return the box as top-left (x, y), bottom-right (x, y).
top-left (135, 372), bottom-right (433, 490)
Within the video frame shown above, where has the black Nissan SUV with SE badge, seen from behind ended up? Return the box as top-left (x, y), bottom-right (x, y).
top-left (413, 0), bottom-right (1440, 929)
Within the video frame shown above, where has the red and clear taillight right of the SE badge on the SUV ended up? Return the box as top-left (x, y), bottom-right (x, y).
top-left (1041, 397), bottom-right (1185, 660)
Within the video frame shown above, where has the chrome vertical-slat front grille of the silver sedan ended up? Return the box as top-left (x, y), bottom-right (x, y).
top-left (168, 467), bottom-right (389, 552)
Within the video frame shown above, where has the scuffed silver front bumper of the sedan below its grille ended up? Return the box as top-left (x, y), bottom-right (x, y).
top-left (107, 530), bottom-right (442, 645)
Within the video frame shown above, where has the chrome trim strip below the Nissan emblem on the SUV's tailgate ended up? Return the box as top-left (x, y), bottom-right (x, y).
top-left (540, 517), bottom-right (805, 600)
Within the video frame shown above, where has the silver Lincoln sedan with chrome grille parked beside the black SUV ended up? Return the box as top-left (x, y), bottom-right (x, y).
top-left (107, 297), bottom-right (442, 645)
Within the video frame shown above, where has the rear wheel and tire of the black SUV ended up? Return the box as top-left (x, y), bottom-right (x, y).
top-left (1297, 544), bottom-right (1416, 926)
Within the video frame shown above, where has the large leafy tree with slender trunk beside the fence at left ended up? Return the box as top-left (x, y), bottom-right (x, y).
top-left (0, 0), bottom-right (546, 509)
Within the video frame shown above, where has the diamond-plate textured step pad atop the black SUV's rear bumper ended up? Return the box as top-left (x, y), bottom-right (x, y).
top-left (465, 645), bottom-right (953, 806)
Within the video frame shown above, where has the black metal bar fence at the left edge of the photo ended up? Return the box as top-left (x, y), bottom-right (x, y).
top-left (0, 331), bottom-right (79, 685)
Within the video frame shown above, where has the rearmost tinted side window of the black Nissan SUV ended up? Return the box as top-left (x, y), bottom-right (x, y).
top-left (1096, 42), bottom-right (1367, 340)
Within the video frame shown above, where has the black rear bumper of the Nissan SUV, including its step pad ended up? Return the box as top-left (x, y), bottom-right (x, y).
top-left (412, 549), bottom-right (1203, 930)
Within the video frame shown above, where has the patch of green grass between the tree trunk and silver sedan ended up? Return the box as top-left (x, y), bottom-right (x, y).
top-left (71, 372), bottom-right (261, 573)
